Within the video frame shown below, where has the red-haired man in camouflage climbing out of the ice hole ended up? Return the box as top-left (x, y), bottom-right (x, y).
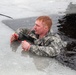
top-left (10, 16), bottom-right (66, 57)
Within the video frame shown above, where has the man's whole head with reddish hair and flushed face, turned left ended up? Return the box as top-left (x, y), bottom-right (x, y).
top-left (34, 16), bottom-right (52, 35)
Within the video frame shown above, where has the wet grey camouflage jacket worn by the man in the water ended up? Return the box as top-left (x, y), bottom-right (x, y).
top-left (16, 28), bottom-right (66, 57)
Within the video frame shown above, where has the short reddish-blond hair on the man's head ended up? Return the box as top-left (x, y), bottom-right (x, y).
top-left (36, 16), bottom-right (52, 30)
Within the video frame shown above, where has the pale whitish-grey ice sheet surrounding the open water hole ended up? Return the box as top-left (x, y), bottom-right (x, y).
top-left (0, 0), bottom-right (76, 75)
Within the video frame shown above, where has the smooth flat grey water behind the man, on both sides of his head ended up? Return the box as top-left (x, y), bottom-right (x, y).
top-left (2, 14), bottom-right (61, 32)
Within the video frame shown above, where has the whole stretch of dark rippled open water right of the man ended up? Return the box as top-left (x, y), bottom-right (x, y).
top-left (57, 14), bottom-right (76, 70)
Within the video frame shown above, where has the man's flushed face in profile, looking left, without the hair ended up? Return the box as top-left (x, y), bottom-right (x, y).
top-left (34, 20), bottom-right (44, 35)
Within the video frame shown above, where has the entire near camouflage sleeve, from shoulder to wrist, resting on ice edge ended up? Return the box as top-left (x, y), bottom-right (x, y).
top-left (30, 33), bottom-right (66, 57)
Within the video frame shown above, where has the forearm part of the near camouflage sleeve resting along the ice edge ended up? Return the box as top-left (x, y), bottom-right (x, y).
top-left (30, 45), bottom-right (60, 57)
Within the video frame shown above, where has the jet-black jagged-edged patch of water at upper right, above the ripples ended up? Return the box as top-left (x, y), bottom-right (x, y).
top-left (58, 14), bottom-right (76, 39)
